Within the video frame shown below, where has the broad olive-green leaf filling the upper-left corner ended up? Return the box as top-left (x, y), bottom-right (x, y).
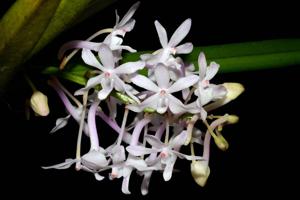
top-left (0, 0), bottom-right (114, 89)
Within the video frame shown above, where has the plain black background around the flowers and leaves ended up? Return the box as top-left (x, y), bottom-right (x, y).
top-left (0, 0), bottom-right (300, 199)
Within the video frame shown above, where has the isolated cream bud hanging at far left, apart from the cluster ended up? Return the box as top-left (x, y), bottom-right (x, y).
top-left (30, 91), bottom-right (50, 116)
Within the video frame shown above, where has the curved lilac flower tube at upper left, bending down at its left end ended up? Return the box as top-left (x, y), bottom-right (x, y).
top-left (58, 40), bottom-right (101, 59)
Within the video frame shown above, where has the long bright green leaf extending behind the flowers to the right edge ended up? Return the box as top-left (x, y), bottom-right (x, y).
top-left (123, 39), bottom-right (300, 72)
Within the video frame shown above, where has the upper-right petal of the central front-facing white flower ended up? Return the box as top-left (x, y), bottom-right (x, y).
top-left (168, 75), bottom-right (199, 93)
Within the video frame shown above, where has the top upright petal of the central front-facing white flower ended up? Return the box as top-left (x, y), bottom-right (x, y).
top-left (154, 63), bottom-right (170, 89)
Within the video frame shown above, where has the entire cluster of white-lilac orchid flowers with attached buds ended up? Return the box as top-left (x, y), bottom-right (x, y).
top-left (43, 3), bottom-right (243, 195)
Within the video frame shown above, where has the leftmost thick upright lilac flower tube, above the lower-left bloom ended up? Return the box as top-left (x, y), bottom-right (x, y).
top-left (88, 100), bottom-right (100, 150)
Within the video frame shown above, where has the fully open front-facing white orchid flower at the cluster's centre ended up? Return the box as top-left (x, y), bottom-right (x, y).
top-left (128, 64), bottom-right (199, 114)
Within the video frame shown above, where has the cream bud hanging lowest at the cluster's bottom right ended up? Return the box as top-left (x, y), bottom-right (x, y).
top-left (191, 160), bottom-right (210, 187)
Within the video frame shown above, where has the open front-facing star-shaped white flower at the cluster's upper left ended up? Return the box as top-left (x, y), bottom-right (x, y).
top-left (75, 44), bottom-right (145, 102)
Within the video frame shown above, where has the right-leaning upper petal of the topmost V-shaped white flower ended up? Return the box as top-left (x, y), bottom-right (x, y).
top-left (168, 19), bottom-right (192, 47)
